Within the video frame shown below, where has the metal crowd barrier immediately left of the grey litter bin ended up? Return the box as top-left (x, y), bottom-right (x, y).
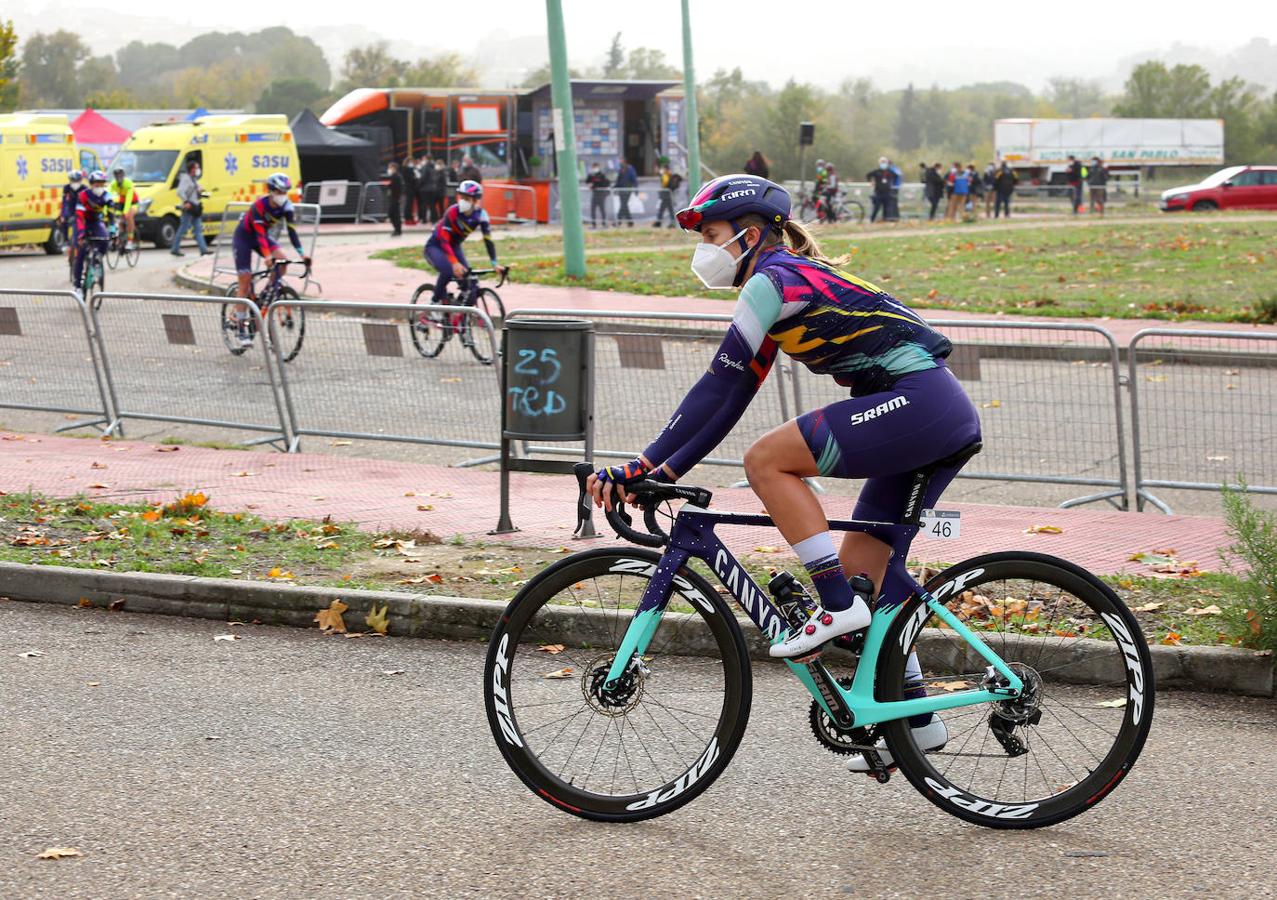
top-left (268, 300), bottom-right (502, 452)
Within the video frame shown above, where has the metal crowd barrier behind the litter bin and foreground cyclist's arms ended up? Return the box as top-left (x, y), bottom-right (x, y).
top-left (507, 309), bottom-right (794, 466)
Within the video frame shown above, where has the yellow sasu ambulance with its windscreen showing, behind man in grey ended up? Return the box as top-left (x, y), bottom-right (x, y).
top-left (111, 115), bottom-right (301, 246)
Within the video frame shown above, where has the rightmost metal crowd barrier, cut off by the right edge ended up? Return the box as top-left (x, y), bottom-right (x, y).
top-left (1128, 328), bottom-right (1277, 513)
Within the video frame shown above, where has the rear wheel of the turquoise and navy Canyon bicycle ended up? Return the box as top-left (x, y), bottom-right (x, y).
top-left (877, 553), bottom-right (1153, 829)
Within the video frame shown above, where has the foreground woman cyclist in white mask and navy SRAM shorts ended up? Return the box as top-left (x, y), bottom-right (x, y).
top-left (589, 175), bottom-right (979, 771)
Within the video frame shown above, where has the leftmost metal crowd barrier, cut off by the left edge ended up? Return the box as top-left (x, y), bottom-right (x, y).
top-left (0, 289), bottom-right (111, 431)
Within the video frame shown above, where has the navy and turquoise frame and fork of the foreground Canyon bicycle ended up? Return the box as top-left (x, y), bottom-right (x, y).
top-left (604, 504), bottom-right (1024, 728)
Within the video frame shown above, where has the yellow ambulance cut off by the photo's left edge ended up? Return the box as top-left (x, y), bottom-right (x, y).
top-left (0, 112), bottom-right (98, 253)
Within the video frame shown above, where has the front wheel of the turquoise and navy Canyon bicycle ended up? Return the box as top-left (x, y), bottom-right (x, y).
top-left (484, 549), bottom-right (751, 822)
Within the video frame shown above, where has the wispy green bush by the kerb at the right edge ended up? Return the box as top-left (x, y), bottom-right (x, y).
top-left (1223, 481), bottom-right (1277, 650)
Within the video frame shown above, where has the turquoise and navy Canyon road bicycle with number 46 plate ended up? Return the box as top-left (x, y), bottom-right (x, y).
top-left (483, 446), bottom-right (1153, 829)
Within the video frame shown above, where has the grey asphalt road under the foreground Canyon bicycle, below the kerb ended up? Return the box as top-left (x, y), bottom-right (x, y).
top-left (7, 601), bottom-right (1277, 899)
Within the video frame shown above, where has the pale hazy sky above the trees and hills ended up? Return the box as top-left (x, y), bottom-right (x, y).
top-left (5, 0), bottom-right (1277, 88)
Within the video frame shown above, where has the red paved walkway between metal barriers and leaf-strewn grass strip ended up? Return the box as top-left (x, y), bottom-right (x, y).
top-left (0, 433), bottom-right (1227, 573)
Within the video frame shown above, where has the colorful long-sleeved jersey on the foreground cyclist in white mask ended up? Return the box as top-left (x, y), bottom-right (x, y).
top-left (644, 248), bottom-right (953, 475)
